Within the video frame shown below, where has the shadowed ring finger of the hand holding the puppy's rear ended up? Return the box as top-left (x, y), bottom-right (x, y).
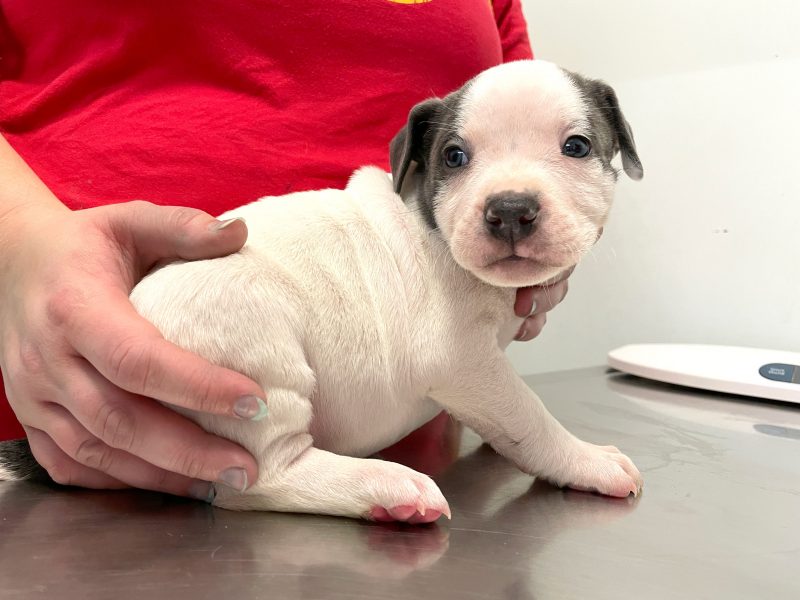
top-left (29, 403), bottom-right (213, 500)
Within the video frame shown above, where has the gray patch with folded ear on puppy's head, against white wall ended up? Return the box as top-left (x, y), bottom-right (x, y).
top-left (562, 69), bottom-right (644, 181)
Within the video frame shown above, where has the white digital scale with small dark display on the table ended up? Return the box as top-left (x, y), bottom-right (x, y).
top-left (608, 344), bottom-right (800, 404)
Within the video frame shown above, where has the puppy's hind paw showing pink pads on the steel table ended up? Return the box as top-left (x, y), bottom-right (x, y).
top-left (363, 462), bottom-right (450, 524)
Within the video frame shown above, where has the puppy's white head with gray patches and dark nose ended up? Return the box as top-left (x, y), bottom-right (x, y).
top-left (390, 60), bottom-right (642, 287)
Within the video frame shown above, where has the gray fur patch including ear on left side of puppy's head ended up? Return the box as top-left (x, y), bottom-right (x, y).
top-left (389, 82), bottom-right (470, 229)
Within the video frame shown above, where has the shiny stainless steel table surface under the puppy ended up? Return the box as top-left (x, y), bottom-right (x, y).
top-left (0, 368), bottom-right (800, 600)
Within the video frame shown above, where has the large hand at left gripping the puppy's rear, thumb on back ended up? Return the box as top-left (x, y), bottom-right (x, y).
top-left (0, 201), bottom-right (266, 499)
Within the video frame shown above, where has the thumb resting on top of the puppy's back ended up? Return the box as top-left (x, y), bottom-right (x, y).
top-left (103, 201), bottom-right (247, 268)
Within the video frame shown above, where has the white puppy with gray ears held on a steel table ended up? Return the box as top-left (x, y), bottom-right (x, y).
top-left (0, 60), bottom-right (642, 523)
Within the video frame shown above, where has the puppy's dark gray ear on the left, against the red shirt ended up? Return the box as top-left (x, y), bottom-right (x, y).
top-left (389, 98), bottom-right (443, 194)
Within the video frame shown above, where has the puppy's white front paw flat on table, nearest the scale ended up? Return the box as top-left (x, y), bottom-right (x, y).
top-left (555, 441), bottom-right (643, 498)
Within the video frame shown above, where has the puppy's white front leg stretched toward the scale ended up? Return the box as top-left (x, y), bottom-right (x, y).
top-left (431, 349), bottom-right (642, 497)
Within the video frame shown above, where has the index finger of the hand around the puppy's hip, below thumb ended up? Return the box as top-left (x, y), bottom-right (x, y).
top-left (51, 288), bottom-right (267, 420)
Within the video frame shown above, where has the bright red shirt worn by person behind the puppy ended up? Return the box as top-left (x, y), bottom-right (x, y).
top-left (0, 0), bottom-right (531, 439)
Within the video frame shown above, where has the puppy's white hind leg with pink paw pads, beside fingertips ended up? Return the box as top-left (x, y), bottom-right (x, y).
top-left (204, 390), bottom-right (450, 523)
